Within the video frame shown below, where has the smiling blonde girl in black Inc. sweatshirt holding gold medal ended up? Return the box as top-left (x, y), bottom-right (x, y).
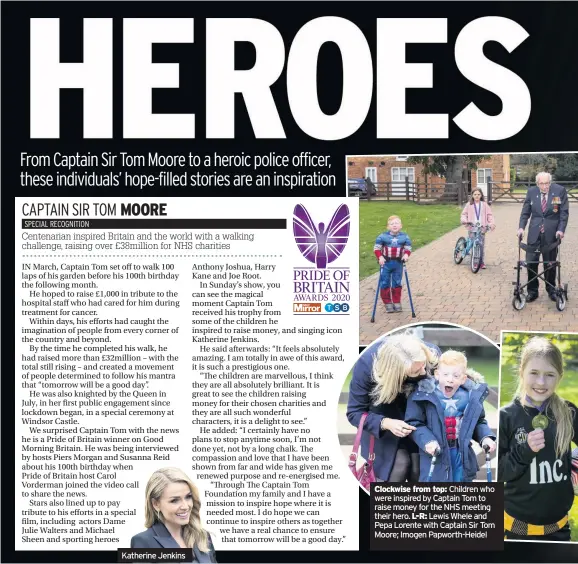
top-left (498, 337), bottom-right (578, 541)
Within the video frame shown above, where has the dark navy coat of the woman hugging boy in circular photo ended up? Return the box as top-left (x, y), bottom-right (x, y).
top-left (347, 338), bottom-right (441, 481)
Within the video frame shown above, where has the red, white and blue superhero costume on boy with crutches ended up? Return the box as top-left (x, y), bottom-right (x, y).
top-left (373, 231), bottom-right (411, 305)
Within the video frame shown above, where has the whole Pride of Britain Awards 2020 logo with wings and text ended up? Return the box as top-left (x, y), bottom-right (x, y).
top-left (293, 204), bottom-right (350, 314)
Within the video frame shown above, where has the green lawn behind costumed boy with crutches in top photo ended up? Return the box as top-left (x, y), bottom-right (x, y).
top-left (359, 201), bottom-right (462, 279)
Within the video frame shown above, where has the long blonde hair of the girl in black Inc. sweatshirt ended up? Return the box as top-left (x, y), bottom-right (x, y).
top-left (514, 337), bottom-right (574, 457)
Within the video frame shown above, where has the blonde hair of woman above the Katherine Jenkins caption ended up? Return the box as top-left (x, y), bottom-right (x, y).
top-left (145, 468), bottom-right (209, 552)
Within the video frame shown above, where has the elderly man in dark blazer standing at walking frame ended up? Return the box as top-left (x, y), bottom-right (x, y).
top-left (518, 172), bottom-right (569, 302)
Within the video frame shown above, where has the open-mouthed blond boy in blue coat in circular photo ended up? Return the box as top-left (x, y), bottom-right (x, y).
top-left (405, 350), bottom-right (496, 482)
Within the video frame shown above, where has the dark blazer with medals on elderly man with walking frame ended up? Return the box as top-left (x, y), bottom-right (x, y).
top-left (519, 184), bottom-right (569, 245)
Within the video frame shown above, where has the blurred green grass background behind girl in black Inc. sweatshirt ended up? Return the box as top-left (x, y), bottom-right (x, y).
top-left (500, 333), bottom-right (578, 542)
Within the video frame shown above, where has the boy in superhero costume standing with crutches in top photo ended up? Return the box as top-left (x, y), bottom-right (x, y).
top-left (373, 215), bottom-right (411, 313)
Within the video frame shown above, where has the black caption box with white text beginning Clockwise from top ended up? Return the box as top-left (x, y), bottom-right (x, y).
top-left (370, 482), bottom-right (504, 550)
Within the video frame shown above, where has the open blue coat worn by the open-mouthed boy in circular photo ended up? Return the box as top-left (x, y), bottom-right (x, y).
top-left (405, 378), bottom-right (496, 482)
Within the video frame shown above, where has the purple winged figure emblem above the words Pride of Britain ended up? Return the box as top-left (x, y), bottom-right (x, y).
top-left (293, 204), bottom-right (349, 268)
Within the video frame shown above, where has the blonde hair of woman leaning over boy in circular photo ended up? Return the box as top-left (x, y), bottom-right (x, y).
top-left (371, 334), bottom-right (437, 405)
